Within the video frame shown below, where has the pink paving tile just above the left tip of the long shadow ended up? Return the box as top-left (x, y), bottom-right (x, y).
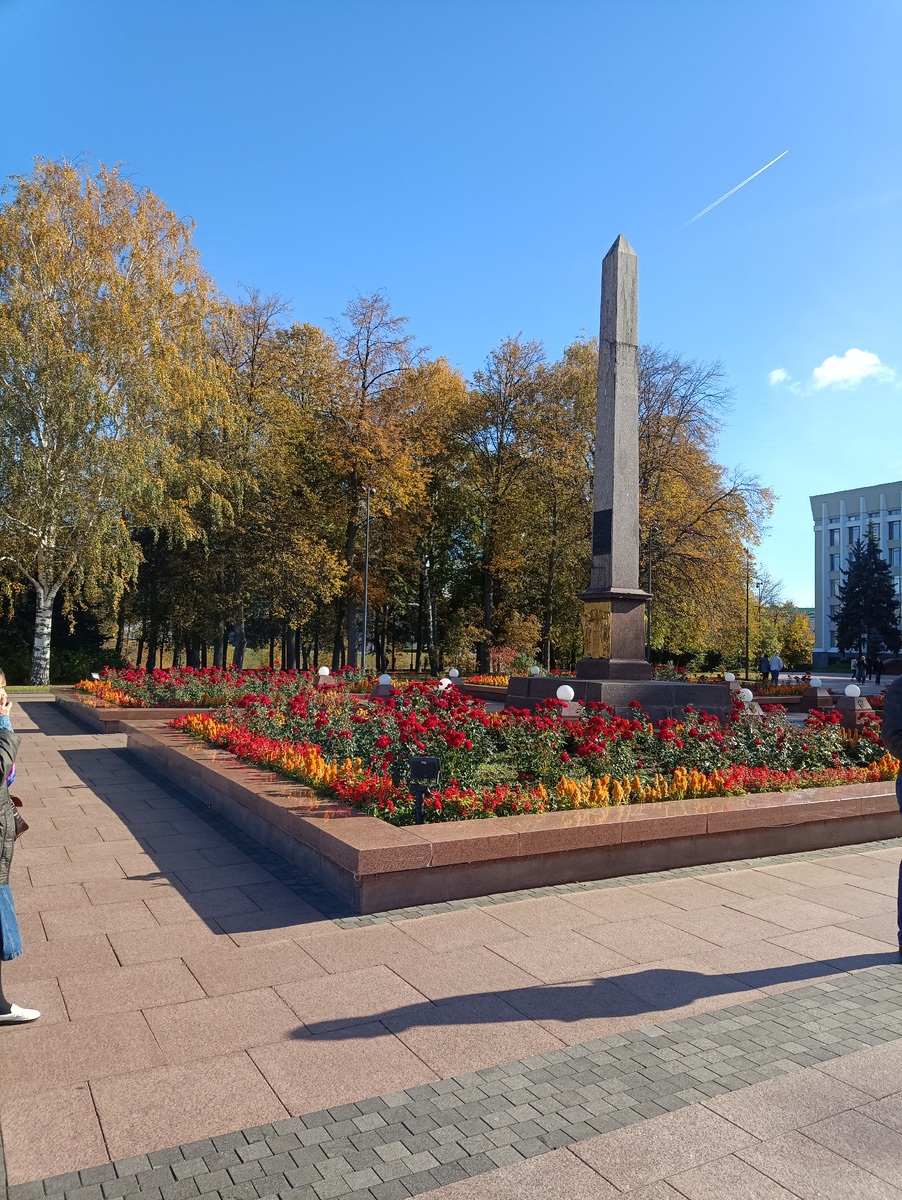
top-left (276, 966), bottom-right (428, 1036)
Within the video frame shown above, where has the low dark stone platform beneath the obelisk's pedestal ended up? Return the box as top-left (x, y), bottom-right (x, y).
top-left (507, 676), bottom-right (733, 721)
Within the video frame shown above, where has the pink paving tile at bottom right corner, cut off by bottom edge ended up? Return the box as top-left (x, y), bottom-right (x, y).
top-left (738, 1133), bottom-right (901, 1200)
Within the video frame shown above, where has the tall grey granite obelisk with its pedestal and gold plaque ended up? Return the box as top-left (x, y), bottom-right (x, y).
top-left (576, 235), bottom-right (651, 679)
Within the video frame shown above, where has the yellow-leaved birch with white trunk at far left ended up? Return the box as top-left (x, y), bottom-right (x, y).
top-left (0, 160), bottom-right (221, 684)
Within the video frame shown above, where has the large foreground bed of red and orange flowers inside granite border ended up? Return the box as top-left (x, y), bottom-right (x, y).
top-left (170, 684), bottom-right (898, 824)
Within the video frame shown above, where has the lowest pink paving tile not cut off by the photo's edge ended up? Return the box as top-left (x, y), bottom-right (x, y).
top-left (571, 1104), bottom-right (754, 1192)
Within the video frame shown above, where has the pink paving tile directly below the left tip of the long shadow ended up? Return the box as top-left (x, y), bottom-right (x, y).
top-left (248, 1022), bottom-right (438, 1113)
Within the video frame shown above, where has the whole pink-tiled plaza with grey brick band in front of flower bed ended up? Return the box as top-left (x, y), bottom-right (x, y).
top-left (0, 697), bottom-right (902, 1200)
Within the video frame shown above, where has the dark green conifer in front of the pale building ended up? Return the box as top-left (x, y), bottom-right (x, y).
top-left (836, 526), bottom-right (902, 654)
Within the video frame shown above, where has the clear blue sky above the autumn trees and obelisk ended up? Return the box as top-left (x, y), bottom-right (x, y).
top-left (0, 0), bottom-right (902, 604)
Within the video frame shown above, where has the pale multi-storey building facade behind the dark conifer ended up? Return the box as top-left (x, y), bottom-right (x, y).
top-left (811, 482), bottom-right (902, 667)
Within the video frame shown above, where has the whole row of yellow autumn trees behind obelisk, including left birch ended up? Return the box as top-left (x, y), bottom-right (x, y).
top-left (0, 160), bottom-right (772, 683)
